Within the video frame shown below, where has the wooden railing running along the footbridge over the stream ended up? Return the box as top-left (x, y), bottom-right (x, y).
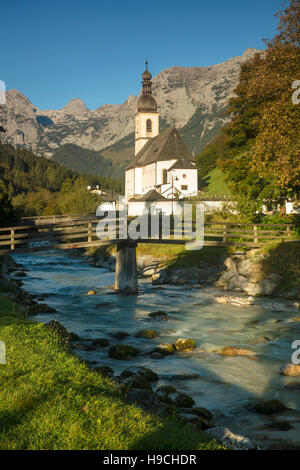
top-left (0, 217), bottom-right (299, 253)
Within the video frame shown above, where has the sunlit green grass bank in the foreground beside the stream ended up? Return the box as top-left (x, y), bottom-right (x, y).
top-left (0, 296), bottom-right (220, 450)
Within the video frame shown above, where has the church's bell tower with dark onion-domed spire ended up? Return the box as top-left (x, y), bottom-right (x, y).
top-left (135, 61), bottom-right (159, 155)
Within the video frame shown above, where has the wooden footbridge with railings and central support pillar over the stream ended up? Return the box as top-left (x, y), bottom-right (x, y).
top-left (0, 215), bottom-right (295, 293)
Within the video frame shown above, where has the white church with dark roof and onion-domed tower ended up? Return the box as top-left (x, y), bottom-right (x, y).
top-left (125, 61), bottom-right (198, 215)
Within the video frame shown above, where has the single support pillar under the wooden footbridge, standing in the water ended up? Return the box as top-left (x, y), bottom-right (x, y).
top-left (115, 240), bottom-right (138, 294)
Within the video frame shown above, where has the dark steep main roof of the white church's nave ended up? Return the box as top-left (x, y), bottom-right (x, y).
top-left (126, 127), bottom-right (195, 170)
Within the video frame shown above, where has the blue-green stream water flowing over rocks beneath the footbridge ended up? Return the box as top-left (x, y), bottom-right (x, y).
top-left (15, 252), bottom-right (300, 446)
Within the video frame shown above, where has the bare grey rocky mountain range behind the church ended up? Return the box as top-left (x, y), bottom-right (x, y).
top-left (0, 49), bottom-right (258, 166)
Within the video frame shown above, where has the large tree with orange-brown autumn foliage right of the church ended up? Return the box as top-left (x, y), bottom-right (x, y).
top-left (219, 0), bottom-right (300, 214)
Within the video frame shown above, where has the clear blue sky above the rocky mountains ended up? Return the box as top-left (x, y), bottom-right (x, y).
top-left (0, 0), bottom-right (282, 109)
